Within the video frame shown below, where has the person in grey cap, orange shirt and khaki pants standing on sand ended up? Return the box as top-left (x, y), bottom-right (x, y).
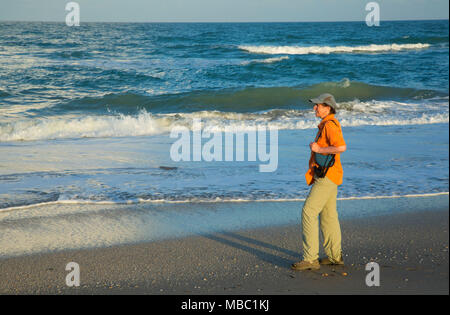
top-left (291, 93), bottom-right (347, 270)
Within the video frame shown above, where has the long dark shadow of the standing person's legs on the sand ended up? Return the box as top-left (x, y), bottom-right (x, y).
top-left (203, 232), bottom-right (300, 269)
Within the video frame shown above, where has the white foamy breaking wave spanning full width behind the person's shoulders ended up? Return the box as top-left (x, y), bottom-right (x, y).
top-left (0, 100), bottom-right (449, 142)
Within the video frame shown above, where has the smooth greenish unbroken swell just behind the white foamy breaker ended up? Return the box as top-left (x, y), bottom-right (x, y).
top-left (28, 79), bottom-right (448, 117)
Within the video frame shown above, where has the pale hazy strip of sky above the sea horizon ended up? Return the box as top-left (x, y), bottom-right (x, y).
top-left (0, 0), bottom-right (449, 23)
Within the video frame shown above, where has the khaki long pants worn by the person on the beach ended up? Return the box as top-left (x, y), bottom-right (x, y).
top-left (302, 176), bottom-right (341, 262)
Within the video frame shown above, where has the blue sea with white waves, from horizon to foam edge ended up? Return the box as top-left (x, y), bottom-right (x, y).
top-left (0, 20), bottom-right (449, 210)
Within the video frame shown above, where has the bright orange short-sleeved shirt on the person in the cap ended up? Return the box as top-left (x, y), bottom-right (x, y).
top-left (305, 114), bottom-right (346, 185)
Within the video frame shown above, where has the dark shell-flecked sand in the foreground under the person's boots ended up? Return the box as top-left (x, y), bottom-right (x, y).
top-left (0, 208), bottom-right (449, 295)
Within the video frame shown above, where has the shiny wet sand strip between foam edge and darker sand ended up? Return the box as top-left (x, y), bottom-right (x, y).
top-left (0, 195), bottom-right (449, 259)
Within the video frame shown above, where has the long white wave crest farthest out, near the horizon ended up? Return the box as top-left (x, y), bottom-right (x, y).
top-left (238, 43), bottom-right (430, 55)
